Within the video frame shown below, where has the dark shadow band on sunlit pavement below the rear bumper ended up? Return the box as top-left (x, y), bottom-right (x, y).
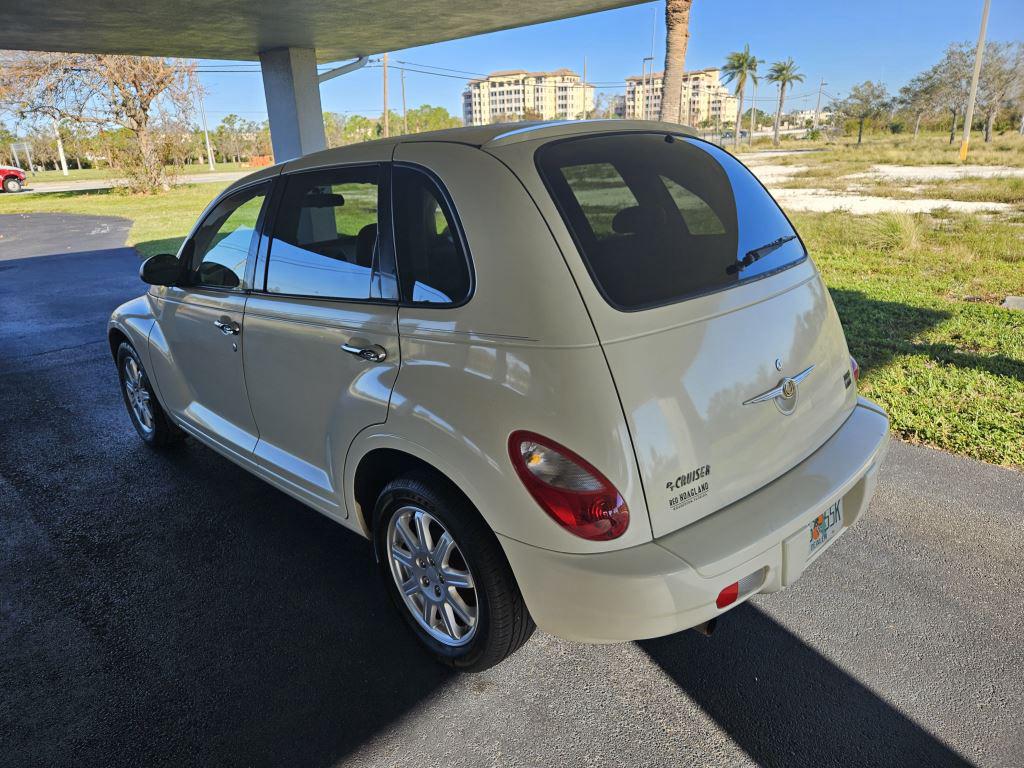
top-left (638, 603), bottom-right (971, 768)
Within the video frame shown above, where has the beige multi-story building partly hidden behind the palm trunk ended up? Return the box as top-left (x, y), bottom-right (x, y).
top-left (624, 69), bottom-right (737, 125)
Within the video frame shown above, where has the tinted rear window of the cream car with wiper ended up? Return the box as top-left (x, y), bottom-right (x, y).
top-left (537, 133), bottom-right (806, 310)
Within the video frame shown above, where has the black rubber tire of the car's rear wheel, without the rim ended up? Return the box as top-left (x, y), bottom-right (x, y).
top-left (374, 471), bottom-right (536, 672)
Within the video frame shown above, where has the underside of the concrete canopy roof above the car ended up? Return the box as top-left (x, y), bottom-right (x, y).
top-left (0, 0), bottom-right (638, 62)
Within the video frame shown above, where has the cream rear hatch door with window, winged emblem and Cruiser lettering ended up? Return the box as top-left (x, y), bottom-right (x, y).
top-left (537, 133), bottom-right (856, 537)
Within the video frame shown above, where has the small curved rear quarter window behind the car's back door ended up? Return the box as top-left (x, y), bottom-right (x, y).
top-left (392, 166), bottom-right (470, 304)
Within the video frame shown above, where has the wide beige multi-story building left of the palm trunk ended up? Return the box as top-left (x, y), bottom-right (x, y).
top-left (462, 70), bottom-right (594, 125)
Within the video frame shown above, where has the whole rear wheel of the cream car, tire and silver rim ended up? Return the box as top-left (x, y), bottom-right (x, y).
top-left (374, 472), bottom-right (535, 672)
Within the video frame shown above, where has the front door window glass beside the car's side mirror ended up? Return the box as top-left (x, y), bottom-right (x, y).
top-left (189, 184), bottom-right (267, 288)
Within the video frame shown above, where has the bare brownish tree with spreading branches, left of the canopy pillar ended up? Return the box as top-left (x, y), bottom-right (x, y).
top-left (0, 51), bottom-right (197, 191)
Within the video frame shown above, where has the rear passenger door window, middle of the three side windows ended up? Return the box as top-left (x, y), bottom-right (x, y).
top-left (266, 166), bottom-right (380, 299)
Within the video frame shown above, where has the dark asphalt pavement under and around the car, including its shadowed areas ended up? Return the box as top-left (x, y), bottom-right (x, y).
top-left (0, 216), bottom-right (1024, 767)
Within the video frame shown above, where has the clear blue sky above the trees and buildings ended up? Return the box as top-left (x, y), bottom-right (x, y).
top-left (195, 0), bottom-right (1024, 127)
